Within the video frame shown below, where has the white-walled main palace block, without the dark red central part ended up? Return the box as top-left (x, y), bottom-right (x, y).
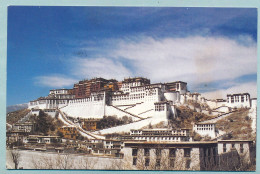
top-left (29, 78), bottom-right (187, 121)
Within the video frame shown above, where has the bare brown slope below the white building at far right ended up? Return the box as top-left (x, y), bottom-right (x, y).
top-left (216, 108), bottom-right (254, 140)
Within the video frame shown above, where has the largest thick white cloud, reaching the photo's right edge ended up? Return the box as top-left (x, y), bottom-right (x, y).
top-left (110, 36), bottom-right (257, 83)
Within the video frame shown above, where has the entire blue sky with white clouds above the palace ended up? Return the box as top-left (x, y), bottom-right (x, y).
top-left (7, 6), bottom-right (257, 105)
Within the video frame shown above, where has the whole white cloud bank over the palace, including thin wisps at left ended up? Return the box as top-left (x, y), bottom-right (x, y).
top-left (33, 36), bottom-right (257, 90)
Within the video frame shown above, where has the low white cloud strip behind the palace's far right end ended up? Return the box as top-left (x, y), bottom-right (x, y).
top-left (202, 82), bottom-right (257, 99)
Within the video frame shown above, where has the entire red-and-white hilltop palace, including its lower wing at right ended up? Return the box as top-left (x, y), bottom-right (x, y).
top-left (29, 77), bottom-right (256, 137)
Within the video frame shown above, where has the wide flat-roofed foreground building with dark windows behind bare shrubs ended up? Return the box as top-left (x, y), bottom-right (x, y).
top-left (122, 141), bottom-right (217, 170)
